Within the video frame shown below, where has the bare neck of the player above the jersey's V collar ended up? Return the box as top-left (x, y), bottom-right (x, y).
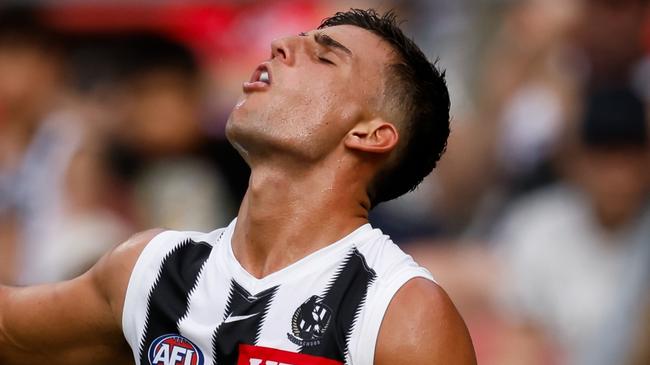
top-left (232, 159), bottom-right (368, 278)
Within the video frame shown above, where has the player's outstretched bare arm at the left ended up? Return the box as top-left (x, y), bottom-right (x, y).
top-left (0, 231), bottom-right (159, 365)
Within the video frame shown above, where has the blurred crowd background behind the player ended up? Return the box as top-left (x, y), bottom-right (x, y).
top-left (0, 0), bottom-right (650, 365)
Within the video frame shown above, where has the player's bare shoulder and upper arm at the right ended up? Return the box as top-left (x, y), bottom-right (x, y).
top-left (375, 278), bottom-right (476, 365)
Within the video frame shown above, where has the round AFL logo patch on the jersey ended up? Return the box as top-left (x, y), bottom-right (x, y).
top-left (148, 334), bottom-right (203, 365)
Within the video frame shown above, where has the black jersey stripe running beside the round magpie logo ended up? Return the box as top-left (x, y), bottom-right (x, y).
top-left (300, 248), bottom-right (376, 363)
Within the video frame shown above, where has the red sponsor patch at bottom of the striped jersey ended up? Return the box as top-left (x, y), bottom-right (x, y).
top-left (237, 344), bottom-right (343, 365)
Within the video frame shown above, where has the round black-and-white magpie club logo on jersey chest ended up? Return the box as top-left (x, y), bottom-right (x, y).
top-left (287, 295), bottom-right (332, 346)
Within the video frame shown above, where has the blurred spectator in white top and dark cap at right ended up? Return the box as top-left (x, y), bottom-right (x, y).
top-left (494, 86), bottom-right (650, 365)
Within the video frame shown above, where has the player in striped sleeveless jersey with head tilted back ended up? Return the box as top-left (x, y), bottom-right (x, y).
top-left (0, 10), bottom-right (475, 365)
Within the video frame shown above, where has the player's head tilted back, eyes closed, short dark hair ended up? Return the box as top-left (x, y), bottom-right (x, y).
top-left (227, 9), bottom-right (450, 207)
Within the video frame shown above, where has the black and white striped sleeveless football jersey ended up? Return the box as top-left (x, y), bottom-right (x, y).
top-left (122, 221), bottom-right (433, 365)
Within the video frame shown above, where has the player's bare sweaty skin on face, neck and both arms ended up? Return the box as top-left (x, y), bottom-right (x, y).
top-left (0, 25), bottom-right (476, 365)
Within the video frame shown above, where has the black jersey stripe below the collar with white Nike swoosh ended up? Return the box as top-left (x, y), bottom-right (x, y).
top-left (212, 280), bottom-right (278, 365)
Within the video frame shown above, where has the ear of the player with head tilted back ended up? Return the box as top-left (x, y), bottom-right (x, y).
top-left (344, 118), bottom-right (399, 153)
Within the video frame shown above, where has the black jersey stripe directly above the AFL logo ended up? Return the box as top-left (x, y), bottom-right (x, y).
top-left (139, 239), bottom-right (212, 365)
